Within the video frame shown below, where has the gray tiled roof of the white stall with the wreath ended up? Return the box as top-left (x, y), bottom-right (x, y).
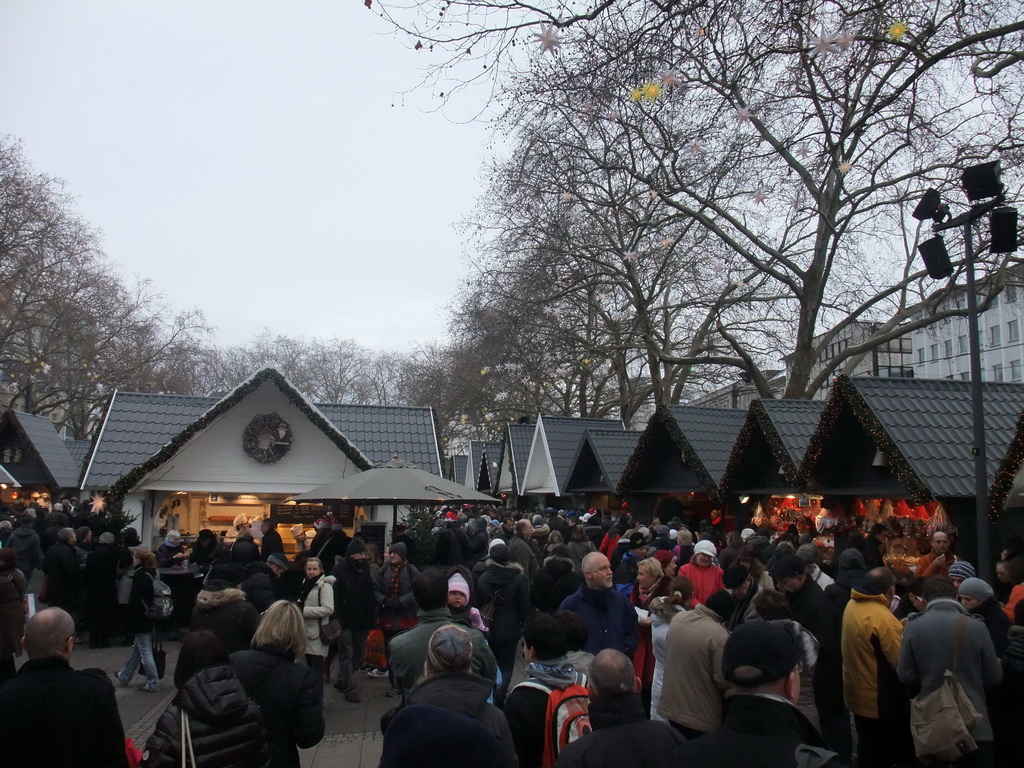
top-left (82, 369), bottom-right (440, 488)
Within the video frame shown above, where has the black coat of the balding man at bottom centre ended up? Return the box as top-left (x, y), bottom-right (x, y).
top-left (556, 693), bottom-right (679, 768)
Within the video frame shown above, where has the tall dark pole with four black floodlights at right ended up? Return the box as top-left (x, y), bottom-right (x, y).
top-left (912, 160), bottom-right (1017, 581)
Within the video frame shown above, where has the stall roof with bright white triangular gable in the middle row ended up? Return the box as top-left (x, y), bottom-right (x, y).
top-left (522, 415), bottom-right (625, 496)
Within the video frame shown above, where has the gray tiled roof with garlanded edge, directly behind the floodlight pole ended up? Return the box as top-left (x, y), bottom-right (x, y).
top-left (805, 376), bottom-right (1024, 503)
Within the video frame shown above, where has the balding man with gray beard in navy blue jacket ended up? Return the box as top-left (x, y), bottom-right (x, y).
top-left (558, 552), bottom-right (637, 656)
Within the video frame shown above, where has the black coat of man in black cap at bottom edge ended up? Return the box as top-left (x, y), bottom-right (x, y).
top-left (667, 694), bottom-right (839, 768)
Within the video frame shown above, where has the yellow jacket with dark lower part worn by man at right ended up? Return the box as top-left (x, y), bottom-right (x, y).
top-left (843, 590), bottom-right (903, 719)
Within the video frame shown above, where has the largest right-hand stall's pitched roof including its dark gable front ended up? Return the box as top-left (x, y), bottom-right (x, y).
top-left (802, 376), bottom-right (1024, 504)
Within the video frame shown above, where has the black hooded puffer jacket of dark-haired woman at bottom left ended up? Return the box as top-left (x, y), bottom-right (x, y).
top-left (143, 665), bottom-right (269, 768)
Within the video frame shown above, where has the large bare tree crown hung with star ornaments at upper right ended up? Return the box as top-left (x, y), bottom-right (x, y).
top-left (446, 0), bottom-right (1024, 398)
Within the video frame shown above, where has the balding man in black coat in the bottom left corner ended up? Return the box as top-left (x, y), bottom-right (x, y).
top-left (0, 608), bottom-right (128, 768)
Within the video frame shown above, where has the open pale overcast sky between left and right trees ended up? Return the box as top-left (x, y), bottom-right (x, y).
top-left (0, 0), bottom-right (490, 349)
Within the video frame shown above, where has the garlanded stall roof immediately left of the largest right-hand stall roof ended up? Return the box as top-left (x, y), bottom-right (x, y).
top-left (722, 399), bottom-right (825, 494)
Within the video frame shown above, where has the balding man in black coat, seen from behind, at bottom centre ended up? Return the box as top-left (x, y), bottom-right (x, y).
top-left (556, 651), bottom-right (685, 768)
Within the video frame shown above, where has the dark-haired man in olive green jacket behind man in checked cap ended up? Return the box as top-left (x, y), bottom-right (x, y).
top-left (390, 570), bottom-right (498, 701)
